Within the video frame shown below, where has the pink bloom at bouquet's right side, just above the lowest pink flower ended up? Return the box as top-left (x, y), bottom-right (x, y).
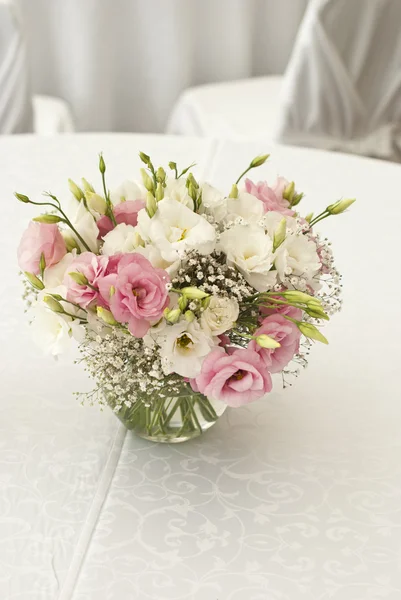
top-left (248, 314), bottom-right (301, 373)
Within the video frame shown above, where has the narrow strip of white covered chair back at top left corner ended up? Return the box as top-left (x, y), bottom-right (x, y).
top-left (0, 0), bottom-right (32, 134)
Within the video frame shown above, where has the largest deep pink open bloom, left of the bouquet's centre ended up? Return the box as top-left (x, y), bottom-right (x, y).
top-left (99, 253), bottom-right (170, 337)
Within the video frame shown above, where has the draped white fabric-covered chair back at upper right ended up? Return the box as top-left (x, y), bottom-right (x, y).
top-left (275, 0), bottom-right (401, 160)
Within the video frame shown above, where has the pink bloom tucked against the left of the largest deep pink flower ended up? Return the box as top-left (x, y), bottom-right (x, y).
top-left (64, 252), bottom-right (122, 308)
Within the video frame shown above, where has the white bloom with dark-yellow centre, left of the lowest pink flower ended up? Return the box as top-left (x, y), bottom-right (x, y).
top-left (157, 321), bottom-right (219, 378)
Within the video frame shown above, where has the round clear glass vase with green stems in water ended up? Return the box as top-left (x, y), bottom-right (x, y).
top-left (106, 393), bottom-right (227, 444)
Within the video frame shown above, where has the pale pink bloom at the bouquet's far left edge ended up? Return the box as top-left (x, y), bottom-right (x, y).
top-left (17, 221), bottom-right (67, 275)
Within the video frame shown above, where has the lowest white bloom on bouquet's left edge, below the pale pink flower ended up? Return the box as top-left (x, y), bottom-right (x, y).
top-left (30, 303), bottom-right (85, 356)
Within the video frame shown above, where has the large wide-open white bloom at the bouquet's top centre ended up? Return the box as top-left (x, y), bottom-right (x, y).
top-left (138, 198), bottom-right (216, 262)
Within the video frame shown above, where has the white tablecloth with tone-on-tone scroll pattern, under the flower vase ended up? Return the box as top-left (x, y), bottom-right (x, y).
top-left (0, 135), bottom-right (401, 600)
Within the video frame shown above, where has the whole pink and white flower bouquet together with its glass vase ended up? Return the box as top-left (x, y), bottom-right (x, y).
top-left (16, 152), bottom-right (353, 442)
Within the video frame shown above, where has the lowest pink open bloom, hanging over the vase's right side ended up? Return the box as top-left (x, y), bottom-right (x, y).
top-left (195, 348), bottom-right (272, 407)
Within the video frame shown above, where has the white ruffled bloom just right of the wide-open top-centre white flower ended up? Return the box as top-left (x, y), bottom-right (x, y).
top-left (219, 225), bottom-right (277, 292)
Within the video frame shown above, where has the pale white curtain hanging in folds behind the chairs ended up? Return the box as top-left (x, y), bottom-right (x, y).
top-left (18, 0), bottom-right (307, 132)
